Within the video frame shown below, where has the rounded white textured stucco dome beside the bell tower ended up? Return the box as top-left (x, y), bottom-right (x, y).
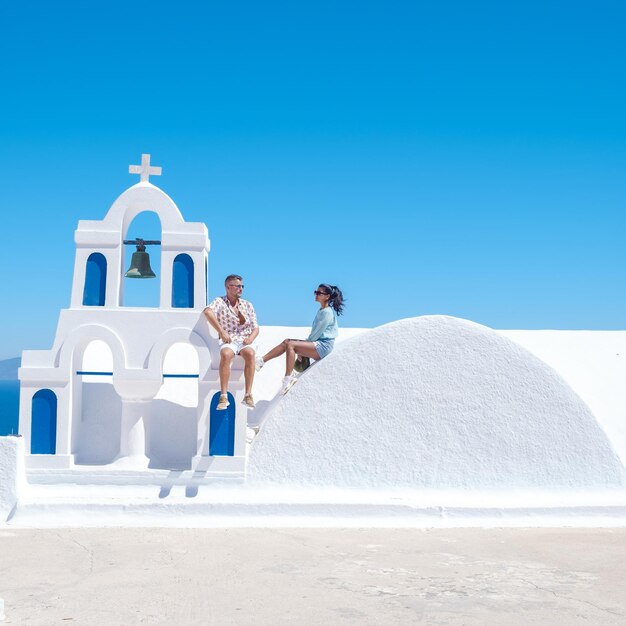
top-left (248, 316), bottom-right (624, 489)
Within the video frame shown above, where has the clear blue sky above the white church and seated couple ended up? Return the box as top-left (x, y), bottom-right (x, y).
top-left (0, 0), bottom-right (626, 358)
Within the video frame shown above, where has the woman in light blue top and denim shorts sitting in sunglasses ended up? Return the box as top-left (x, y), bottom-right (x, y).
top-left (256, 284), bottom-right (343, 393)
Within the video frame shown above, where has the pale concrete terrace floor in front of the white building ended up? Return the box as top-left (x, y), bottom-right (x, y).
top-left (0, 528), bottom-right (626, 626)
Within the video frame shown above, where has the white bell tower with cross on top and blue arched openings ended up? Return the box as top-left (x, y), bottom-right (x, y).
top-left (19, 154), bottom-right (247, 473)
